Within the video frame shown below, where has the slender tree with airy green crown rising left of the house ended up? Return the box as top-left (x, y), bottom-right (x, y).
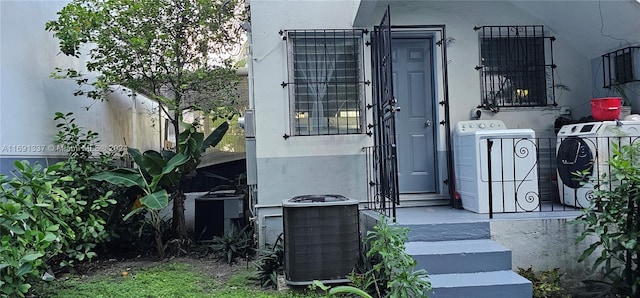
top-left (45, 0), bottom-right (244, 239)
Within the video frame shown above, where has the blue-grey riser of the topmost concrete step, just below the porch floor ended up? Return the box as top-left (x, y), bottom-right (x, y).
top-left (400, 220), bottom-right (491, 242)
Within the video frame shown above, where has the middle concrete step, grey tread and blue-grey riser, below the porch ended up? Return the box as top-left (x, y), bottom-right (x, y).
top-left (405, 239), bottom-right (511, 274)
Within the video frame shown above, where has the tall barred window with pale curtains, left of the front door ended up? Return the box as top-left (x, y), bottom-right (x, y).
top-left (283, 30), bottom-right (364, 136)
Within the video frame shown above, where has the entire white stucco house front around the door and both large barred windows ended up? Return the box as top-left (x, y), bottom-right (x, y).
top-left (250, 0), bottom-right (604, 247)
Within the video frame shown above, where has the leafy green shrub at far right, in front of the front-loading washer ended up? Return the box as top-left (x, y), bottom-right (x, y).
top-left (577, 142), bottom-right (640, 297)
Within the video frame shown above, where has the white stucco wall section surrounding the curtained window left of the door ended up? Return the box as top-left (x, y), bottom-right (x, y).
top-left (250, 0), bottom-right (372, 244)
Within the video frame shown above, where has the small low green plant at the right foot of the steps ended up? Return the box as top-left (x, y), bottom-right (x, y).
top-left (518, 267), bottom-right (571, 298)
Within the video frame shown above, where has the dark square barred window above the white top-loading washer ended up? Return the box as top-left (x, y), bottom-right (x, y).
top-left (474, 26), bottom-right (555, 108)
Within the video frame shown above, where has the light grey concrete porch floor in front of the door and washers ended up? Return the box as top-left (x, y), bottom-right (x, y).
top-left (396, 204), bottom-right (581, 225)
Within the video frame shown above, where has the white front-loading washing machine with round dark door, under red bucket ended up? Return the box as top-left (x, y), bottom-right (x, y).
top-left (556, 121), bottom-right (640, 208)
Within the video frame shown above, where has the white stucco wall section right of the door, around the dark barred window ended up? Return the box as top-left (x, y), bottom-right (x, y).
top-left (352, 1), bottom-right (591, 137)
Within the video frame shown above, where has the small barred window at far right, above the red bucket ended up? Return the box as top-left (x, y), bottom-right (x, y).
top-left (602, 46), bottom-right (640, 88)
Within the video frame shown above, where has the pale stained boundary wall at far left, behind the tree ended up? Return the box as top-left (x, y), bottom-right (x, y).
top-left (0, 0), bottom-right (161, 172)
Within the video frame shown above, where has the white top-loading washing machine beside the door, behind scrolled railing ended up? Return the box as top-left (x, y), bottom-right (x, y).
top-left (453, 120), bottom-right (540, 213)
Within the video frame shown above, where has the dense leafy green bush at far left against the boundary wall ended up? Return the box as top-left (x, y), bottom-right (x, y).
top-left (0, 113), bottom-right (125, 296)
